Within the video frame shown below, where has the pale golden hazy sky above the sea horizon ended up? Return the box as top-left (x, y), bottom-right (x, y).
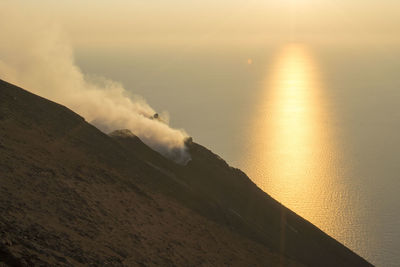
top-left (0, 0), bottom-right (400, 46)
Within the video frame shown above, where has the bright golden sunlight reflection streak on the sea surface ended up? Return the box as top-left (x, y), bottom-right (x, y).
top-left (244, 44), bottom-right (364, 258)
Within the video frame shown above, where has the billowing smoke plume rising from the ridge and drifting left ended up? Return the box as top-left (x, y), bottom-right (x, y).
top-left (0, 8), bottom-right (190, 164)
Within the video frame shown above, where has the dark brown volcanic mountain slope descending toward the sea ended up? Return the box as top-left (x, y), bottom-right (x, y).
top-left (0, 80), bottom-right (370, 266)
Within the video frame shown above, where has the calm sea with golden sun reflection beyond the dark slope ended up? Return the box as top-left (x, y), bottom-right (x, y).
top-left (76, 44), bottom-right (400, 266)
